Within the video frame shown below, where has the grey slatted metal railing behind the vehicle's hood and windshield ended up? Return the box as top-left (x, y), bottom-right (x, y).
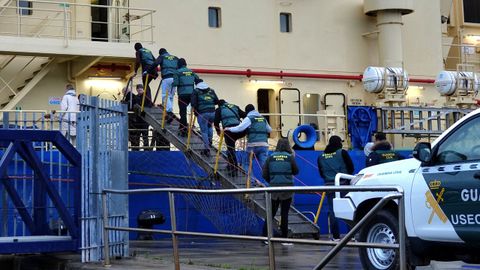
top-left (376, 107), bottom-right (472, 138)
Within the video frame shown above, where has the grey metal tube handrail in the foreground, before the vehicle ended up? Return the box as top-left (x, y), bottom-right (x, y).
top-left (102, 186), bottom-right (406, 270)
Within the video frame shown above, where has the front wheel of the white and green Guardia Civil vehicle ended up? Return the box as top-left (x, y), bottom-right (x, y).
top-left (359, 210), bottom-right (400, 270)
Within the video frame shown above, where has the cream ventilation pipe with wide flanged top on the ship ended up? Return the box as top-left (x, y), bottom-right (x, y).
top-left (364, 0), bottom-right (413, 67)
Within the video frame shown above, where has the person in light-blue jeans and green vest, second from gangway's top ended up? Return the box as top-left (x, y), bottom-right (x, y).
top-left (154, 48), bottom-right (178, 123)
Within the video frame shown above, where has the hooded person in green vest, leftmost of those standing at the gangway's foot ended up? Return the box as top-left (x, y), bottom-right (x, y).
top-left (262, 138), bottom-right (298, 242)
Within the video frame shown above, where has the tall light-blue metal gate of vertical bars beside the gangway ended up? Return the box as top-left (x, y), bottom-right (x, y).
top-left (77, 96), bottom-right (128, 262)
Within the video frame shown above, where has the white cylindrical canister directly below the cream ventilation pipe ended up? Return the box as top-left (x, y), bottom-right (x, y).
top-left (362, 67), bottom-right (408, 93)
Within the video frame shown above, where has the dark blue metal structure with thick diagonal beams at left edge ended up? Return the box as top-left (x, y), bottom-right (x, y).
top-left (0, 129), bottom-right (81, 253)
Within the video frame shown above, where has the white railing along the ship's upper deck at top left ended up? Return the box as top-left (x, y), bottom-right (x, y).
top-left (0, 0), bottom-right (155, 45)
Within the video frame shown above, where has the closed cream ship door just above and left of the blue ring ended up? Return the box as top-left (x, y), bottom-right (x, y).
top-left (279, 88), bottom-right (301, 138)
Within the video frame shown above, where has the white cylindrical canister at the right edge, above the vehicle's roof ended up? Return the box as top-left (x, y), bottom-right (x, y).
top-left (435, 70), bottom-right (480, 96)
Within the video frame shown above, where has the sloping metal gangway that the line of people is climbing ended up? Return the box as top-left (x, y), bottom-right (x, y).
top-left (137, 106), bottom-right (319, 238)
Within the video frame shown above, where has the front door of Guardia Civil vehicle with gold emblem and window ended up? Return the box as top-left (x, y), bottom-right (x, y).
top-left (411, 115), bottom-right (480, 243)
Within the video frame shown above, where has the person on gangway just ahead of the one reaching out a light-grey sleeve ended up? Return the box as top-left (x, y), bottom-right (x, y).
top-left (214, 99), bottom-right (247, 176)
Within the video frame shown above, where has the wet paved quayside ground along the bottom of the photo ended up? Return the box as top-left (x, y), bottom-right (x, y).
top-left (0, 238), bottom-right (480, 270)
